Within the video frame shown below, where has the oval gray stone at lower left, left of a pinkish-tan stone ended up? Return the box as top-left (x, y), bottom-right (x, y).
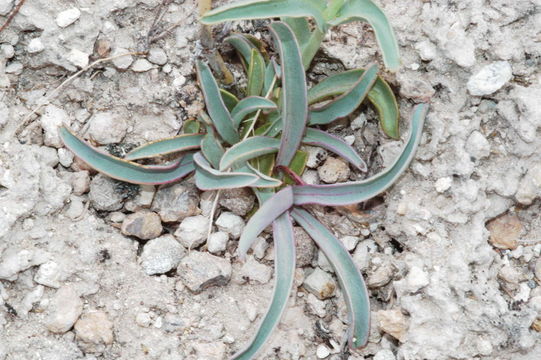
top-left (45, 286), bottom-right (83, 334)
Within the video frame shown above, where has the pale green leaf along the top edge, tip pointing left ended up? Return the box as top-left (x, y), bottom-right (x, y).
top-left (201, 0), bottom-right (326, 31)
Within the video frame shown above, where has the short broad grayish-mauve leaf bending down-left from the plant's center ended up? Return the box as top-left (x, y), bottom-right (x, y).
top-left (237, 186), bottom-right (293, 260)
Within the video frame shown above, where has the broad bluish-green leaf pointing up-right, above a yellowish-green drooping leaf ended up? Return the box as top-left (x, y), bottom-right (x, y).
top-left (309, 65), bottom-right (378, 125)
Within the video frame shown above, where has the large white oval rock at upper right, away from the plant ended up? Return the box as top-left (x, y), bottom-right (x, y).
top-left (467, 61), bottom-right (513, 96)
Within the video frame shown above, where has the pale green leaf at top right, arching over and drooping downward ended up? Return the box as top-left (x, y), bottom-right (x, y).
top-left (329, 0), bottom-right (400, 71)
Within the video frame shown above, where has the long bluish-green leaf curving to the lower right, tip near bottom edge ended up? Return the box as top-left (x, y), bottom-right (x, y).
top-left (291, 208), bottom-right (370, 348)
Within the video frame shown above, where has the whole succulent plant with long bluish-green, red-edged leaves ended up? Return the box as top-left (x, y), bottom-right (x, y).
top-left (60, 0), bottom-right (427, 359)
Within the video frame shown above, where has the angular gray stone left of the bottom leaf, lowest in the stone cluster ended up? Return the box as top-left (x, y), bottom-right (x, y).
top-left (177, 251), bottom-right (231, 292)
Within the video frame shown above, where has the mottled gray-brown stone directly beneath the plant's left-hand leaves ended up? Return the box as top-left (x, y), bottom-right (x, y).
top-left (151, 184), bottom-right (200, 222)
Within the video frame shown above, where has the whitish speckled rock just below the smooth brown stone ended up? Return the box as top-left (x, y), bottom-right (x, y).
top-left (140, 235), bottom-right (186, 275)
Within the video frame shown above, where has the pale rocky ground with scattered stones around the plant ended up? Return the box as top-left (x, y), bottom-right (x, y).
top-left (0, 0), bottom-right (541, 360)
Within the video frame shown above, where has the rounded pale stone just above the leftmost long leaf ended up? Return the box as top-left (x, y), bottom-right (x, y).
top-left (88, 111), bottom-right (128, 145)
